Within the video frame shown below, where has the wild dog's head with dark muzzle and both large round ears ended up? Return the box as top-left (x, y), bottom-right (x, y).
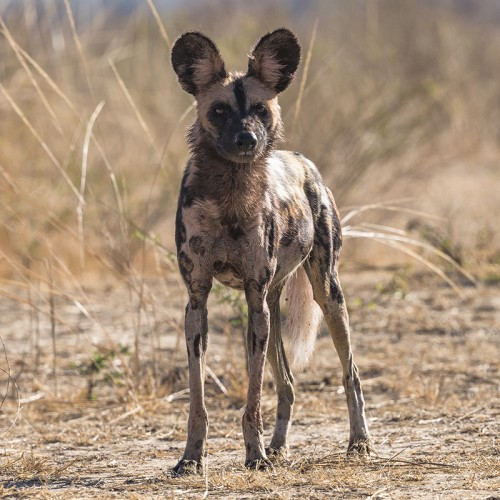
top-left (172, 29), bottom-right (300, 164)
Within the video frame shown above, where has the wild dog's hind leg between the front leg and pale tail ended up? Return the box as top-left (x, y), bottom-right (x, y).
top-left (266, 287), bottom-right (295, 458)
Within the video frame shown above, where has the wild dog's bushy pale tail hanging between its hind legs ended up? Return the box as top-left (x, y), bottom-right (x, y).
top-left (283, 266), bottom-right (323, 369)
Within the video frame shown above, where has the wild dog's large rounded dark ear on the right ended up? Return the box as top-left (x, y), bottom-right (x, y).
top-left (247, 28), bottom-right (300, 92)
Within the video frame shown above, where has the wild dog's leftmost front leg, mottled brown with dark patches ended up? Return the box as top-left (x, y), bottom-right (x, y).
top-left (173, 281), bottom-right (211, 475)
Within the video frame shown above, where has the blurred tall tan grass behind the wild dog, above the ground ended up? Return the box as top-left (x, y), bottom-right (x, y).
top-left (0, 0), bottom-right (500, 286)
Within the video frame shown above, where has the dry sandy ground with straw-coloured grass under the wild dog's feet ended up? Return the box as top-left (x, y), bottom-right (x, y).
top-left (0, 271), bottom-right (500, 499)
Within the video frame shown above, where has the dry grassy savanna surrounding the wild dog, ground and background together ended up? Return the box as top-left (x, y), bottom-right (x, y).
top-left (0, 0), bottom-right (500, 498)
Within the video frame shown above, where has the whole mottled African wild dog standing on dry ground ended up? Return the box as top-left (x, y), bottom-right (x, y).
top-left (172, 29), bottom-right (370, 474)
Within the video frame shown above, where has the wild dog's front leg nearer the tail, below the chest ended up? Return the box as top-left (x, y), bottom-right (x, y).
top-left (242, 279), bottom-right (272, 469)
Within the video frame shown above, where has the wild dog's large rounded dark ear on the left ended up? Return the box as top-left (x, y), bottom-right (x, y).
top-left (171, 31), bottom-right (227, 96)
